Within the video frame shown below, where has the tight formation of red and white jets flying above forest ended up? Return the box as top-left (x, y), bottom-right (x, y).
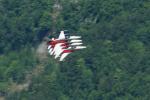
top-left (47, 31), bottom-right (86, 61)
